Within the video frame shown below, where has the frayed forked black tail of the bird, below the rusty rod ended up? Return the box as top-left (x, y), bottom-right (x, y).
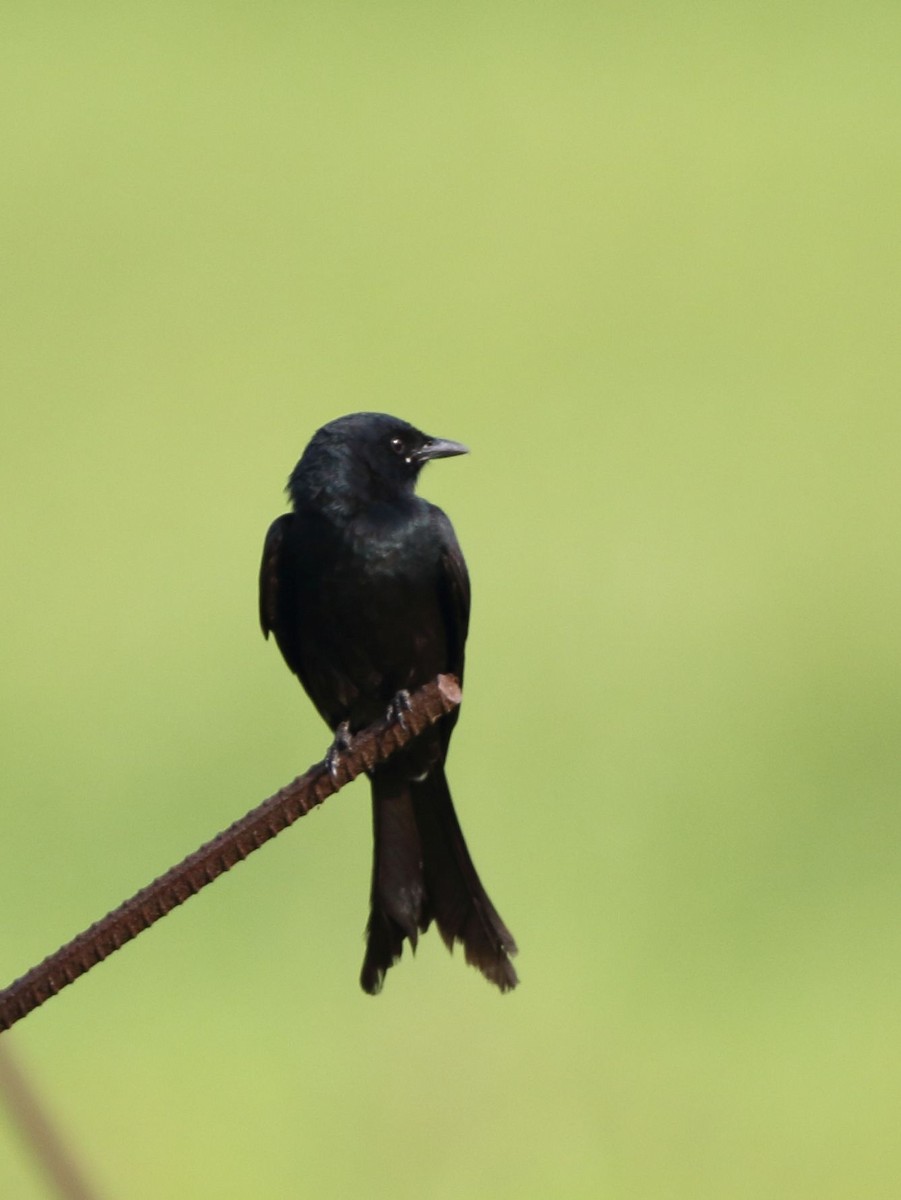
top-left (360, 766), bottom-right (517, 994)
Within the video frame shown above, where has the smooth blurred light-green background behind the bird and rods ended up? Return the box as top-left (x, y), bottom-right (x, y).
top-left (0, 0), bottom-right (901, 1200)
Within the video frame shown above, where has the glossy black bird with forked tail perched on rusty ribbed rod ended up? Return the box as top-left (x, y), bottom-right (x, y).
top-left (259, 413), bottom-right (517, 995)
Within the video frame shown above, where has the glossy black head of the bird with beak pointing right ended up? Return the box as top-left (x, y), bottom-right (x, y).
top-left (288, 413), bottom-right (468, 508)
